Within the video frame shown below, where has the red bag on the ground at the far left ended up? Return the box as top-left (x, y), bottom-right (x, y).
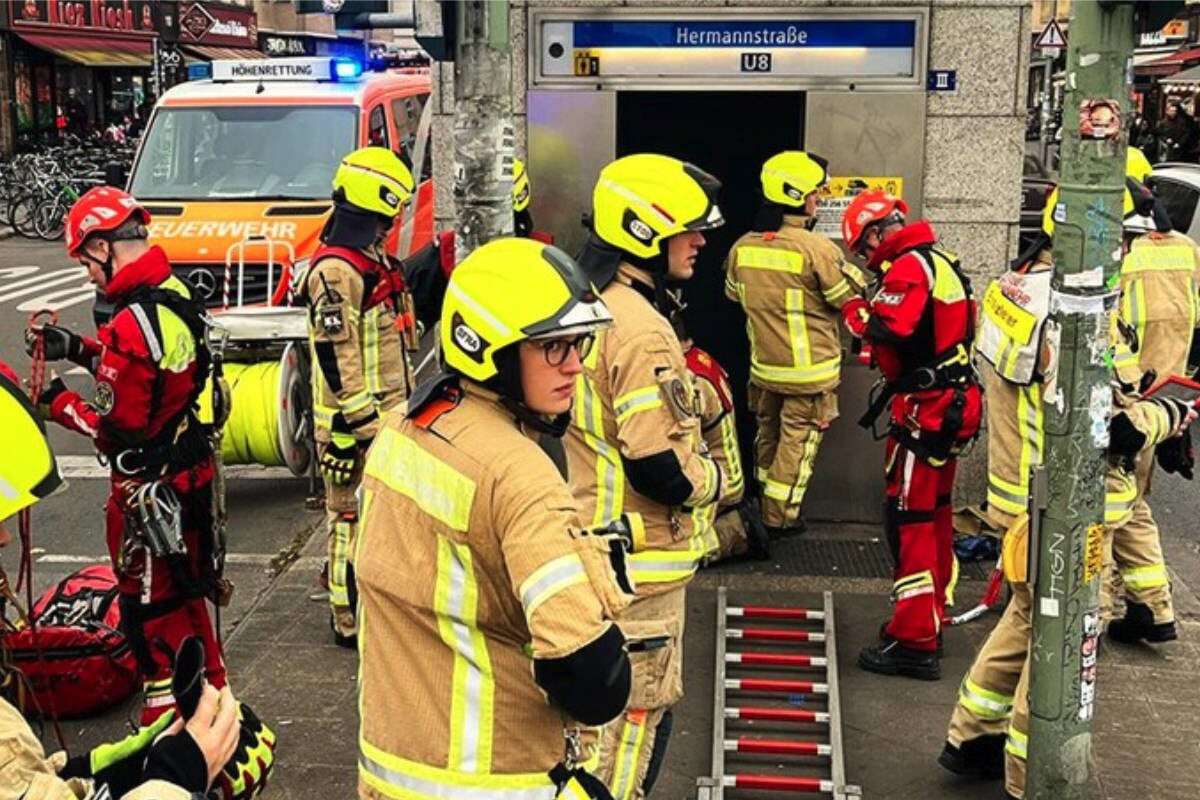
top-left (2, 565), bottom-right (139, 718)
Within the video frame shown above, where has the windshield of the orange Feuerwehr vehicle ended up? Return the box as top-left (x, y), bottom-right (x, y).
top-left (130, 106), bottom-right (358, 200)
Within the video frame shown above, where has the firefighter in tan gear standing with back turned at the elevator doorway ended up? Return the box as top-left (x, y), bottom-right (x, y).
top-left (725, 150), bottom-right (866, 537)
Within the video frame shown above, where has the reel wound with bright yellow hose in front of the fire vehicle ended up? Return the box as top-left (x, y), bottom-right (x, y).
top-left (200, 345), bottom-right (312, 475)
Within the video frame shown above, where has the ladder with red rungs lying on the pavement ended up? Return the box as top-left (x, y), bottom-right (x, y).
top-left (696, 587), bottom-right (862, 800)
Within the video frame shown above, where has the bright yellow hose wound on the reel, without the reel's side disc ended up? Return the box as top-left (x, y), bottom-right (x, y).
top-left (200, 361), bottom-right (284, 467)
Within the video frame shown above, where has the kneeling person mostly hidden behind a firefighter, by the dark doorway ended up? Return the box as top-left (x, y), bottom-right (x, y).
top-left (683, 338), bottom-right (770, 564)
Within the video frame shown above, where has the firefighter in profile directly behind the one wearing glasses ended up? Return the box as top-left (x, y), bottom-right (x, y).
top-left (566, 154), bottom-right (734, 800)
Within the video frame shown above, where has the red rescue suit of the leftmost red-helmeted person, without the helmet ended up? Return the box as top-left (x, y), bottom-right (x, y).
top-left (50, 247), bottom-right (226, 724)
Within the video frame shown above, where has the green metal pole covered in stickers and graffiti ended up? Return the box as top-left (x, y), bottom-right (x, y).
top-left (1025, 0), bottom-right (1134, 800)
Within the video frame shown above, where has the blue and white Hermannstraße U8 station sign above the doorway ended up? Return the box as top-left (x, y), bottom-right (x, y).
top-left (540, 14), bottom-right (919, 82)
